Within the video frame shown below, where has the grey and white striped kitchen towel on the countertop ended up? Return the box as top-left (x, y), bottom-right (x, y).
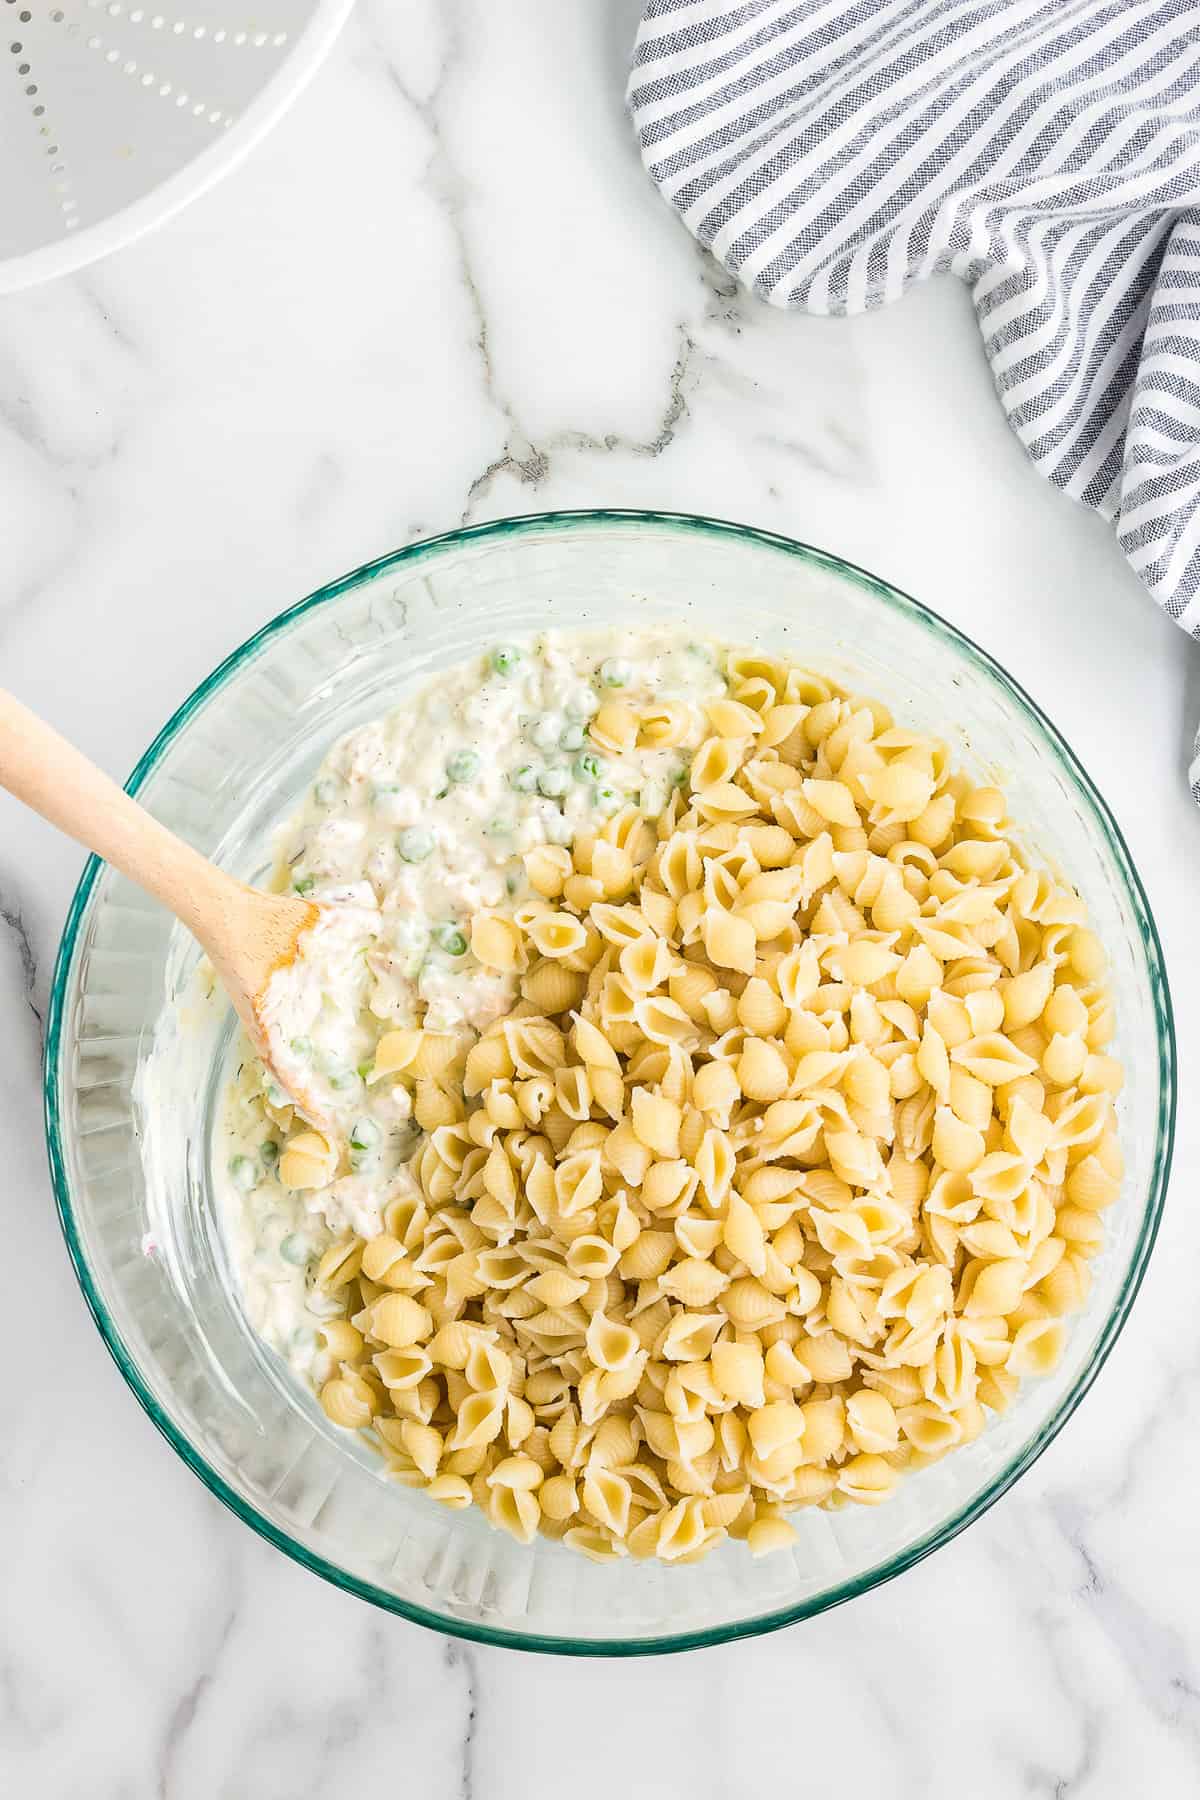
top-left (630, 0), bottom-right (1200, 801)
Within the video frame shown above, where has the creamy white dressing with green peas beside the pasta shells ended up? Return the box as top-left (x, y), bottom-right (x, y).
top-left (214, 630), bottom-right (725, 1381)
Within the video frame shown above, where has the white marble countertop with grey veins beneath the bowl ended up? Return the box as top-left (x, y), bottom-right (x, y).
top-left (0, 0), bottom-right (1200, 1800)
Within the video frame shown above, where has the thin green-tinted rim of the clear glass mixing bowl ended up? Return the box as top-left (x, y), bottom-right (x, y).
top-left (43, 508), bottom-right (1177, 1656)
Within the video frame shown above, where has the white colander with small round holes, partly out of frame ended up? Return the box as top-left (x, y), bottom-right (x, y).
top-left (0, 0), bottom-right (353, 293)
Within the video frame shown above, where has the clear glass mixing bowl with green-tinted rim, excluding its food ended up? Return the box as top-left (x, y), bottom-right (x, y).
top-left (45, 511), bottom-right (1175, 1654)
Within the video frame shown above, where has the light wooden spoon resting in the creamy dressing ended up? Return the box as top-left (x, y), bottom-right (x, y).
top-left (0, 688), bottom-right (324, 1125)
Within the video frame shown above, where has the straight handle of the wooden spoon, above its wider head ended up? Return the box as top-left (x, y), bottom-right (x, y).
top-left (0, 688), bottom-right (239, 941)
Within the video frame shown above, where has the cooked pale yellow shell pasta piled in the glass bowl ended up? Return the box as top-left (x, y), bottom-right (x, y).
top-left (220, 630), bottom-right (1123, 1562)
